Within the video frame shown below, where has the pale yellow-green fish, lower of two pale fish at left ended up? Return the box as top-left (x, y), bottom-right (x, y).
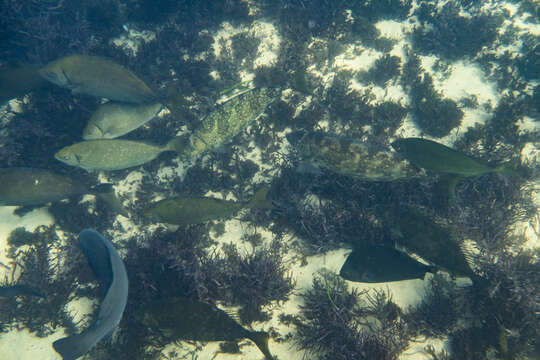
top-left (54, 137), bottom-right (185, 171)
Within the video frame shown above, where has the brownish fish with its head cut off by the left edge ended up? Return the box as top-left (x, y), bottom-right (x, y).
top-left (0, 167), bottom-right (127, 216)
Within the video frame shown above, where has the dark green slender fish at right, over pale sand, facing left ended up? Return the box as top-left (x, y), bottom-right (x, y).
top-left (391, 138), bottom-right (515, 177)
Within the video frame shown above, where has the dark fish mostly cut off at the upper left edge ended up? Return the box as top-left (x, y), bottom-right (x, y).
top-left (0, 62), bottom-right (47, 105)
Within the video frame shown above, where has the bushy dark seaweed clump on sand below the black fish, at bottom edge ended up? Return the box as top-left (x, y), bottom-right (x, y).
top-left (294, 271), bottom-right (408, 360)
